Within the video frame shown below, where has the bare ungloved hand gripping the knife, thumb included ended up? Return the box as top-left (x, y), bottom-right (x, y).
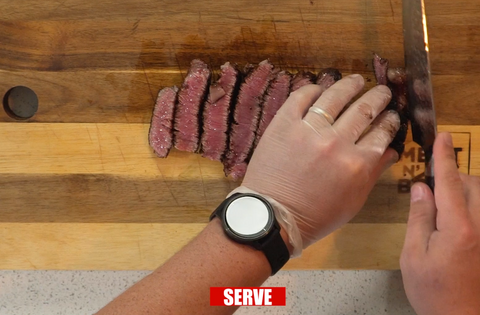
top-left (400, 133), bottom-right (480, 315)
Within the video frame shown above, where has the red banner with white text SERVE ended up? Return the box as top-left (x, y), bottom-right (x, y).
top-left (210, 287), bottom-right (287, 306)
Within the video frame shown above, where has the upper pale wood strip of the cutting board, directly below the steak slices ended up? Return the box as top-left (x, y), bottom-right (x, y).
top-left (0, 123), bottom-right (472, 180)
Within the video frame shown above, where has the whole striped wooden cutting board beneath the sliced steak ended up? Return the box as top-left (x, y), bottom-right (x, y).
top-left (0, 0), bottom-right (480, 270)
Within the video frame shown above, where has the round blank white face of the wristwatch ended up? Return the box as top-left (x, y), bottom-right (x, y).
top-left (225, 196), bottom-right (273, 238)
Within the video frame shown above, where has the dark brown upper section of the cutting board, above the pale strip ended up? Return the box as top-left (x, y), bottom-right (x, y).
top-left (0, 0), bottom-right (480, 125)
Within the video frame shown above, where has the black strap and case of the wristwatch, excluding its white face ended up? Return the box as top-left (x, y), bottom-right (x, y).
top-left (210, 193), bottom-right (290, 276)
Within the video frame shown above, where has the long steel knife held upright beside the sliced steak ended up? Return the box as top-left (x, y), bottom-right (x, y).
top-left (402, 0), bottom-right (437, 191)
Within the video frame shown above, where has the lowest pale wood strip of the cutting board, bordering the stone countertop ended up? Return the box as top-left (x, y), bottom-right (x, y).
top-left (0, 223), bottom-right (405, 270)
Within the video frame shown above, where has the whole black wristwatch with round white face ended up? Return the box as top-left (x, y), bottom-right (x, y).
top-left (210, 193), bottom-right (290, 275)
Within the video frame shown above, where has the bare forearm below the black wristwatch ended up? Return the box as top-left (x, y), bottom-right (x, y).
top-left (98, 219), bottom-right (280, 315)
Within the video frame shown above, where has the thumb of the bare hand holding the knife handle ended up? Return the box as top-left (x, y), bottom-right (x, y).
top-left (404, 183), bottom-right (437, 252)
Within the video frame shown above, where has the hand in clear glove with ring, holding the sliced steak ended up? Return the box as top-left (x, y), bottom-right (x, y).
top-left (234, 75), bottom-right (400, 256)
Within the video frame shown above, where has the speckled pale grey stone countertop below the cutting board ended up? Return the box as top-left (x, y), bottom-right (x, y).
top-left (0, 271), bottom-right (415, 315)
